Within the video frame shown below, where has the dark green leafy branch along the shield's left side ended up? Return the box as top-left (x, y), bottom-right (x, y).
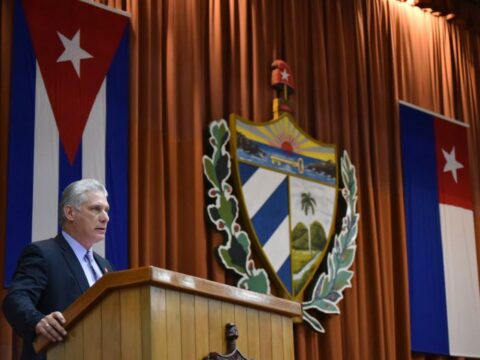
top-left (203, 119), bottom-right (270, 294)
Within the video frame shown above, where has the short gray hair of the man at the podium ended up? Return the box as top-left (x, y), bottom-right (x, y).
top-left (58, 179), bottom-right (108, 226)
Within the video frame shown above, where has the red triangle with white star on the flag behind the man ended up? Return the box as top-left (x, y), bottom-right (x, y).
top-left (22, 0), bottom-right (128, 163)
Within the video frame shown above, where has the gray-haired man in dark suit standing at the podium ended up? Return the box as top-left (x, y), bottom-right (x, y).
top-left (3, 179), bottom-right (112, 360)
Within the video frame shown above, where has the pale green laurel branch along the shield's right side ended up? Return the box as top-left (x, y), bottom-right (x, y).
top-left (302, 151), bottom-right (360, 333)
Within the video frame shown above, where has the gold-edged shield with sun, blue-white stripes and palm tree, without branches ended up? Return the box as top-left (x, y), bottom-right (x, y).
top-left (230, 113), bottom-right (338, 299)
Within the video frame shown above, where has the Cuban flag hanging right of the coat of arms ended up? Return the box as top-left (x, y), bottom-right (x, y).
top-left (400, 103), bottom-right (480, 357)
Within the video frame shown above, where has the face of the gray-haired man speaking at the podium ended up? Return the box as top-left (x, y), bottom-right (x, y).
top-left (65, 191), bottom-right (110, 248)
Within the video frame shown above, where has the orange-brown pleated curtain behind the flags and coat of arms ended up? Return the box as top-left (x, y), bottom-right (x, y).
top-left (0, 0), bottom-right (480, 360)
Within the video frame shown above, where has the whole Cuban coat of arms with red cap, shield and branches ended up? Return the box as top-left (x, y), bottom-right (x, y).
top-left (203, 60), bottom-right (359, 332)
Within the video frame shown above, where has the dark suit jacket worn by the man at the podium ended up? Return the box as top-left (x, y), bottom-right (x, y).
top-left (3, 234), bottom-right (113, 360)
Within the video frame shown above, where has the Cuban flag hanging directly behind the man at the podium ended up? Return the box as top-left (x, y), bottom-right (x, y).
top-left (5, 0), bottom-right (129, 285)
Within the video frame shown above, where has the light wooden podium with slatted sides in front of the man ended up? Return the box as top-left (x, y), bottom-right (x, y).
top-left (34, 267), bottom-right (301, 360)
